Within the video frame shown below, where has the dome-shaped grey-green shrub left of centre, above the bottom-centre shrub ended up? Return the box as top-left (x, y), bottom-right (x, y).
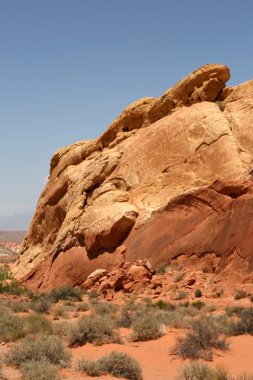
top-left (69, 315), bottom-right (120, 346)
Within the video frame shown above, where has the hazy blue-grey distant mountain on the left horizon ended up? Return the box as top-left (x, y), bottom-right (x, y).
top-left (0, 213), bottom-right (33, 231)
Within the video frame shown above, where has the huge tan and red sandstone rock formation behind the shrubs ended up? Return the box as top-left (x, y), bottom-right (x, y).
top-left (15, 65), bottom-right (253, 291)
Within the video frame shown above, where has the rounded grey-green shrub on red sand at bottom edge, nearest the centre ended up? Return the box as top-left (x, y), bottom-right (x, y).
top-left (97, 351), bottom-right (142, 380)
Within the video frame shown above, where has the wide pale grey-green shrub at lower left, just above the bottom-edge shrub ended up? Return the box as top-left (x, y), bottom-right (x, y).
top-left (5, 335), bottom-right (70, 367)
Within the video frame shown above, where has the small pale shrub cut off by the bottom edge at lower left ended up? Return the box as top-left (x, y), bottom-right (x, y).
top-left (20, 360), bottom-right (60, 380)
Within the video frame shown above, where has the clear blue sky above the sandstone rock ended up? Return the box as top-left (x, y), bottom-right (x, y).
top-left (0, 0), bottom-right (253, 216)
